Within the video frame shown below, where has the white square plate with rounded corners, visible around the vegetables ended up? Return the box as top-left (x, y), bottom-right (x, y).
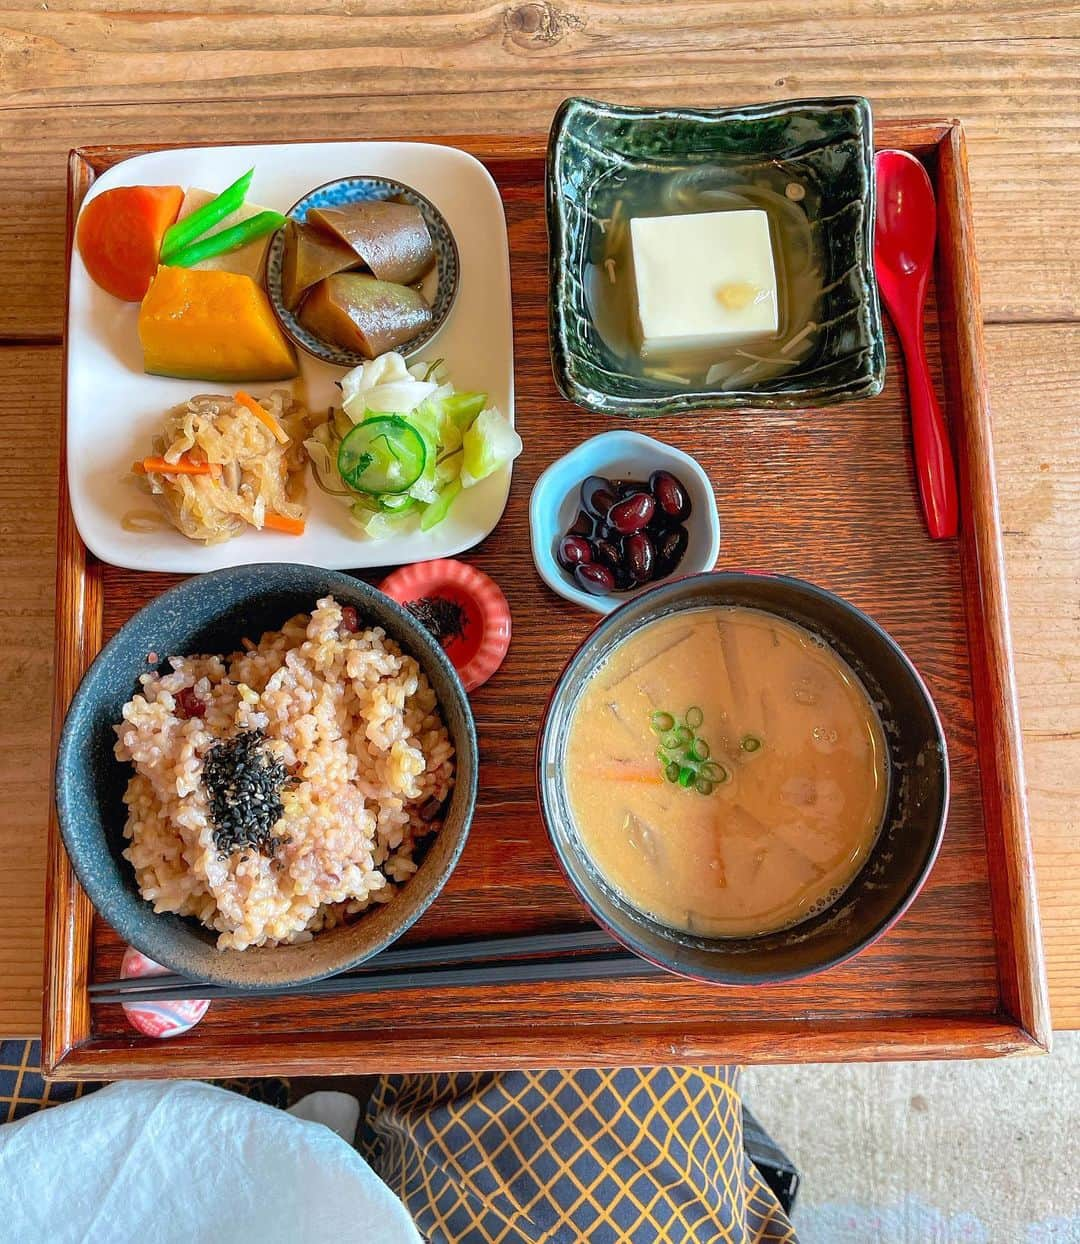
top-left (67, 142), bottom-right (514, 573)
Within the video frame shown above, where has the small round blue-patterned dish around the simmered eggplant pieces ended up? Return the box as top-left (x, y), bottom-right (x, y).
top-left (266, 175), bottom-right (460, 367)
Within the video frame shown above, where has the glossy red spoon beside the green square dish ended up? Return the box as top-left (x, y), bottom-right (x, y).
top-left (873, 151), bottom-right (958, 540)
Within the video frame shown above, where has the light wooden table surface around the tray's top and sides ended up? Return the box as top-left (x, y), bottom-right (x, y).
top-left (0, 0), bottom-right (1080, 1036)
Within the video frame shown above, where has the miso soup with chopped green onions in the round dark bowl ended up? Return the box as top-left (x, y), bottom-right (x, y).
top-left (566, 607), bottom-right (888, 937)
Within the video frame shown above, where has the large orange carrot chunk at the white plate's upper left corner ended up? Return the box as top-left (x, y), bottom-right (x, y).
top-left (76, 185), bottom-right (184, 302)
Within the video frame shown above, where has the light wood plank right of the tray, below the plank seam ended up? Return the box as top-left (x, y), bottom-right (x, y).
top-left (988, 327), bottom-right (1080, 1028)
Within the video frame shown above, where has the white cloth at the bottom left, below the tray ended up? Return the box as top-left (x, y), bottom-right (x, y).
top-left (0, 1081), bottom-right (421, 1244)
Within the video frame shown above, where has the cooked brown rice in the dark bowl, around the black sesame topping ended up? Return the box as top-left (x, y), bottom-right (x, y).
top-left (116, 596), bottom-right (454, 950)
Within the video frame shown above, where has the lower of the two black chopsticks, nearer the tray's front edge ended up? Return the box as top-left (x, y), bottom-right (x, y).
top-left (92, 952), bottom-right (664, 1004)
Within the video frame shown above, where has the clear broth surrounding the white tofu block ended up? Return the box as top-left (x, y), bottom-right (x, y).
top-left (584, 160), bottom-right (822, 392)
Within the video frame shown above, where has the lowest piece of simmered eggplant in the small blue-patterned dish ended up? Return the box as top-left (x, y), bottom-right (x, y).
top-left (300, 272), bottom-right (432, 358)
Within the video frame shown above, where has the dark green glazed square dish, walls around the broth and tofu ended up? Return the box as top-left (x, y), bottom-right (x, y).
top-left (547, 96), bottom-right (885, 417)
